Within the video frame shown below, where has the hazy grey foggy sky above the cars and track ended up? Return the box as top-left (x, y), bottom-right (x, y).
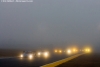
top-left (0, 0), bottom-right (100, 48)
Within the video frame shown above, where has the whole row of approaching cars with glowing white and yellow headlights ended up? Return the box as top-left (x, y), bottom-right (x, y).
top-left (20, 48), bottom-right (91, 59)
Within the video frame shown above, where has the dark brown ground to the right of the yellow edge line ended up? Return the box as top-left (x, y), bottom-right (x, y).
top-left (57, 53), bottom-right (100, 67)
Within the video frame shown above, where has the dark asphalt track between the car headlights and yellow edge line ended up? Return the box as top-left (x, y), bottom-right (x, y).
top-left (0, 54), bottom-right (71, 67)
